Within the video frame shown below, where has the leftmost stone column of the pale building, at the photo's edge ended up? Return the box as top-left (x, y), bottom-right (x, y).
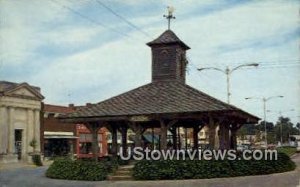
top-left (0, 106), bottom-right (9, 154)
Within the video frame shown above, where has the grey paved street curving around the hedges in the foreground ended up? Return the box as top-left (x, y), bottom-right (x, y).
top-left (0, 154), bottom-right (300, 187)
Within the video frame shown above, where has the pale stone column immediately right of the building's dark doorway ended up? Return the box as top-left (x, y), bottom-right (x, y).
top-left (25, 109), bottom-right (34, 153)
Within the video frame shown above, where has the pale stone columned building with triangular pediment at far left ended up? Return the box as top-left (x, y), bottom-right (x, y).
top-left (0, 81), bottom-right (44, 163)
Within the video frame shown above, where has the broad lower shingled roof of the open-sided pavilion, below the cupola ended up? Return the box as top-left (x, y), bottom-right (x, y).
top-left (66, 81), bottom-right (256, 118)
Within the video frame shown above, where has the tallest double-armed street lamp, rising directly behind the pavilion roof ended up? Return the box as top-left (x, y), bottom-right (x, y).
top-left (198, 63), bottom-right (259, 104)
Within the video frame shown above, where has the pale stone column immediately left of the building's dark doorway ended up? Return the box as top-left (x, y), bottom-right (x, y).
top-left (8, 107), bottom-right (15, 154)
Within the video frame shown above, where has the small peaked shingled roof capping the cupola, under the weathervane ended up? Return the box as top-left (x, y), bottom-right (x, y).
top-left (147, 30), bottom-right (190, 49)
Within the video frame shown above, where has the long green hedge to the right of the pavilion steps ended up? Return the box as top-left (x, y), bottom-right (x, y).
top-left (133, 153), bottom-right (296, 180)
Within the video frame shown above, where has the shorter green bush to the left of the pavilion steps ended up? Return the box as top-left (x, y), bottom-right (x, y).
top-left (46, 158), bottom-right (109, 181)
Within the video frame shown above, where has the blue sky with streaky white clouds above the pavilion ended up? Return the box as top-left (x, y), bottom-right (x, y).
top-left (0, 0), bottom-right (300, 125)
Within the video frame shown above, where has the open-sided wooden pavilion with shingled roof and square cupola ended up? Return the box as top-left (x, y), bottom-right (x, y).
top-left (60, 29), bottom-right (259, 158)
